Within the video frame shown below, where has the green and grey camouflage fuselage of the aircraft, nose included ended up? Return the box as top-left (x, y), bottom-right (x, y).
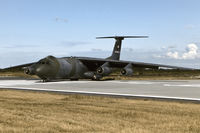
top-left (25, 56), bottom-right (91, 80)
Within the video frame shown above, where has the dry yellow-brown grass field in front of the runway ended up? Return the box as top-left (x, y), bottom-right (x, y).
top-left (0, 90), bottom-right (200, 133)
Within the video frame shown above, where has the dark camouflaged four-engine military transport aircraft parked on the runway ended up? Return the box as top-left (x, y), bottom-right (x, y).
top-left (3, 36), bottom-right (195, 81)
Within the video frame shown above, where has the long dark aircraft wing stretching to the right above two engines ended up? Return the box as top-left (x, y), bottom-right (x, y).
top-left (77, 57), bottom-right (195, 71)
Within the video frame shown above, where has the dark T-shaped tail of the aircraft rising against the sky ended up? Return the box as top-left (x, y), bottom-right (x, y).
top-left (96, 36), bottom-right (148, 60)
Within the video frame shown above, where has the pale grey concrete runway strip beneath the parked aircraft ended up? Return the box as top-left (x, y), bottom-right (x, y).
top-left (0, 80), bottom-right (200, 102)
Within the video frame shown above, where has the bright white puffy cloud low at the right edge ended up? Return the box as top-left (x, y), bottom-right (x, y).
top-left (166, 43), bottom-right (200, 60)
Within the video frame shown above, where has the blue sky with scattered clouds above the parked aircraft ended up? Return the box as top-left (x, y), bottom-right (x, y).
top-left (0, 0), bottom-right (200, 68)
